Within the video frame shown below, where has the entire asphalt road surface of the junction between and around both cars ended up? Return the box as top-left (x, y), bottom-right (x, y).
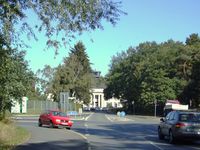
top-left (14, 112), bottom-right (200, 150)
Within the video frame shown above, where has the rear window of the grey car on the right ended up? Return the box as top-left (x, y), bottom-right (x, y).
top-left (179, 113), bottom-right (200, 123)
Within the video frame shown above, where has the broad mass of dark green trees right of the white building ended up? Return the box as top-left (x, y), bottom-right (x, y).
top-left (104, 34), bottom-right (200, 113)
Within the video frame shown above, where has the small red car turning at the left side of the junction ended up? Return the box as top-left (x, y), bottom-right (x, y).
top-left (38, 110), bottom-right (73, 129)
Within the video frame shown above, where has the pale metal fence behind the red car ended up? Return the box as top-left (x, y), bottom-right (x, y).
top-left (27, 100), bottom-right (78, 114)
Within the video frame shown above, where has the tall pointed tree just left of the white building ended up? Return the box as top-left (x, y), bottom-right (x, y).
top-left (52, 42), bottom-right (91, 104)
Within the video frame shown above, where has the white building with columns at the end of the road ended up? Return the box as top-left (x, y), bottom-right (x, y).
top-left (89, 88), bottom-right (122, 108)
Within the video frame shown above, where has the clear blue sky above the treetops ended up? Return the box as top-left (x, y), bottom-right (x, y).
top-left (26, 0), bottom-right (200, 75)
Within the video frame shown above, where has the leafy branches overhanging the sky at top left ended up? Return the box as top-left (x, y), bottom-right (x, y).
top-left (0, 0), bottom-right (124, 49)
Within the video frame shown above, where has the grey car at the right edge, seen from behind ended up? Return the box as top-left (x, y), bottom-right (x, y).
top-left (158, 111), bottom-right (200, 143)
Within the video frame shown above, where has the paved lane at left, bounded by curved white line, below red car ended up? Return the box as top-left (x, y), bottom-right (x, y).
top-left (16, 117), bottom-right (88, 150)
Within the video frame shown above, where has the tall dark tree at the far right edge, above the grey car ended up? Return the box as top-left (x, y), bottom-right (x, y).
top-left (179, 34), bottom-right (200, 108)
